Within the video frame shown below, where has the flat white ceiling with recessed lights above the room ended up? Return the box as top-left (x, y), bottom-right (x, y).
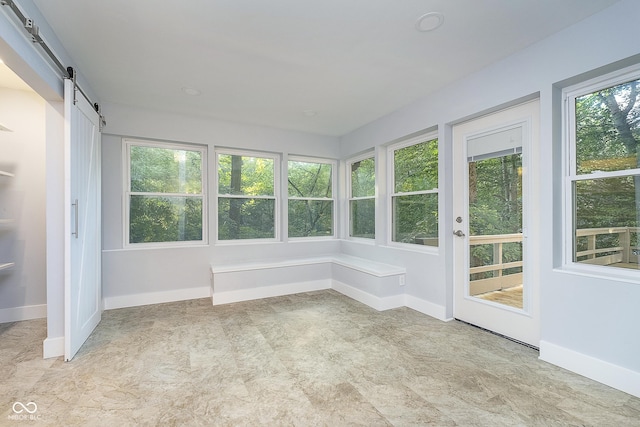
top-left (34, 0), bottom-right (617, 136)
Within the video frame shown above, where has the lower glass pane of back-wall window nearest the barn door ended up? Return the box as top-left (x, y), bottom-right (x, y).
top-left (129, 196), bottom-right (202, 243)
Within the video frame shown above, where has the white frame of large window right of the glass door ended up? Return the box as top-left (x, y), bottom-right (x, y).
top-left (562, 64), bottom-right (640, 283)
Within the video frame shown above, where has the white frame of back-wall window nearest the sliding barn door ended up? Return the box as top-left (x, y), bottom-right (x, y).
top-left (122, 138), bottom-right (209, 249)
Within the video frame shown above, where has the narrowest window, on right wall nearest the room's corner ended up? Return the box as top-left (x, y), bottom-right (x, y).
top-left (348, 156), bottom-right (376, 239)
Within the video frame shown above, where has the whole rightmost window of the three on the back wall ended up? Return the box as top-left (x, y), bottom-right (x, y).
top-left (287, 158), bottom-right (334, 237)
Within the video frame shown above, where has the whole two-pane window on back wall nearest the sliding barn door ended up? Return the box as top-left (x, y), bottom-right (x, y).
top-left (124, 140), bottom-right (207, 245)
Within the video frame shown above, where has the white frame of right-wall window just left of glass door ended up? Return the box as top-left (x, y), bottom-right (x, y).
top-left (387, 131), bottom-right (440, 252)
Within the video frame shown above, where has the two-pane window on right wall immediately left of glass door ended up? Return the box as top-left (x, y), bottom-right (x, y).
top-left (389, 137), bottom-right (438, 246)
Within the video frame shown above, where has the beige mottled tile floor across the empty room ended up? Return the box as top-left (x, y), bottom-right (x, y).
top-left (0, 291), bottom-right (640, 426)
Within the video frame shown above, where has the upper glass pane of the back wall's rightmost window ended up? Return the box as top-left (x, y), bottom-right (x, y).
top-left (288, 161), bottom-right (331, 198)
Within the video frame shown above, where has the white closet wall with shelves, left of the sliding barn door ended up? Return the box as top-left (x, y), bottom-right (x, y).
top-left (0, 88), bottom-right (46, 322)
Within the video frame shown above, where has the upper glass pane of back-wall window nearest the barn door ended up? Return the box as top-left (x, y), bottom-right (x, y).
top-left (130, 145), bottom-right (202, 194)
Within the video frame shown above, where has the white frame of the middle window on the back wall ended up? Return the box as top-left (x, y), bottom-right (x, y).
top-left (214, 148), bottom-right (282, 245)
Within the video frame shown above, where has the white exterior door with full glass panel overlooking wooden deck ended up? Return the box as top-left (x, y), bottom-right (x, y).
top-left (453, 101), bottom-right (539, 347)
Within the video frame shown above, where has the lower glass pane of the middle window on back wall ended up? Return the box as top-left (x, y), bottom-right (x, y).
top-left (218, 197), bottom-right (276, 240)
